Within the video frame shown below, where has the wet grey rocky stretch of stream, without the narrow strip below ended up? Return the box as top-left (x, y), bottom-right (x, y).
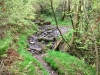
top-left (29, 25), bottom-right (68, 54)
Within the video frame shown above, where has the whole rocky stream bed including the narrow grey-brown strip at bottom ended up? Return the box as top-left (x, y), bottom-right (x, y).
top-left (28, 18), bottom-right (70, 75)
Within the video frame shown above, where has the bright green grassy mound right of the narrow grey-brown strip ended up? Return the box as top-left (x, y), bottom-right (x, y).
top-left (44, 51), bottom-right (96, 75)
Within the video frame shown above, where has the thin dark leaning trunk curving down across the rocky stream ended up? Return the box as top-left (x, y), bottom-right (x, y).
top-left (51, 0), bottom-right (71, 49)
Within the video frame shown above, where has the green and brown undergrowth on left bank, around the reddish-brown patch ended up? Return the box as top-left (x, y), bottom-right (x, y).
top-left (0, 22), bottom-right (48, 75)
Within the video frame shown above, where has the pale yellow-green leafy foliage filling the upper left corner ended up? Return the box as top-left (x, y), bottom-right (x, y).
top-left (0, 0), bottom-right (34, 25)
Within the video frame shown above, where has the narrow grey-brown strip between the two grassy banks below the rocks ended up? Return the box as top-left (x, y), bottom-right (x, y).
top-left (33, 54), bottom-right (58, 75)
